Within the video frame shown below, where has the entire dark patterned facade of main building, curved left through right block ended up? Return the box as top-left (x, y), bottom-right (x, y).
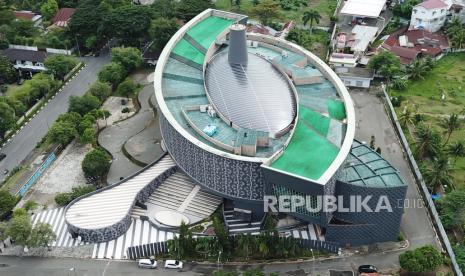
top-left (160, 116), bottom-right (407, 246)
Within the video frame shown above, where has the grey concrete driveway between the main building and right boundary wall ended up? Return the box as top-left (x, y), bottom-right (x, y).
top-left (350, 90), bottom-right (440, 248)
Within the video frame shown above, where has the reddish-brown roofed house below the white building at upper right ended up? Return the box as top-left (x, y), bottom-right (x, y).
top-left (381, 28), bottom-right (449, 64)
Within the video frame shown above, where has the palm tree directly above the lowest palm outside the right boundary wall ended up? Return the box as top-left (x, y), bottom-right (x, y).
top-left (415, 124), bottom-right (441, 158)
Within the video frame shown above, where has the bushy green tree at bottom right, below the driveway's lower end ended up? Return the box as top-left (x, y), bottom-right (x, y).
top-left (399, 245), bottom-right (443, 273)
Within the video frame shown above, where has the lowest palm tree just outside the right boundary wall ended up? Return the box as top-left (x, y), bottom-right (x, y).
top-left (424, 154), bottom-right (453, 192)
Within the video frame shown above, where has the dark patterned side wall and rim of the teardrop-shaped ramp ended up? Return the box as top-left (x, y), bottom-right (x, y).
top-left (65, 156), bottom-right (178, 243)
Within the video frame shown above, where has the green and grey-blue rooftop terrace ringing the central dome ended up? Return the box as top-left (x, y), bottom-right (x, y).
top-left (158, 10), bottom-right (348, 181)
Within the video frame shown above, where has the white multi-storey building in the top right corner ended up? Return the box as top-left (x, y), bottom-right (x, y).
top-left (410, 0), bottom-right (450, 32)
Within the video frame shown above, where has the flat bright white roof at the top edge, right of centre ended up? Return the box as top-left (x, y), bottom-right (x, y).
top-left (340, 0), bottom-right (386, 18)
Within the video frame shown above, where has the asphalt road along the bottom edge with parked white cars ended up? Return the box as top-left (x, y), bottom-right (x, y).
top-left (0, 254), bottom-right (398, 276)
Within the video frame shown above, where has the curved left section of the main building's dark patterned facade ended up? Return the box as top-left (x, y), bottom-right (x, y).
top-left (160, 115), bottom-right (265, 201)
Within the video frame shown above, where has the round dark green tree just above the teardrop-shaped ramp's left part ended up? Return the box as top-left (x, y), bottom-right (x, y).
top-left (82, 148), bottom-right (110, 179)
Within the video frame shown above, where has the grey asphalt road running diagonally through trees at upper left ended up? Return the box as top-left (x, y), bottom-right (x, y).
top-left (0, 54), bottom-right (110, 182)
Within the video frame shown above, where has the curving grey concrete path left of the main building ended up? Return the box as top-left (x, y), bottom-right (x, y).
top-left (98, 84), bottom-right (161, 184)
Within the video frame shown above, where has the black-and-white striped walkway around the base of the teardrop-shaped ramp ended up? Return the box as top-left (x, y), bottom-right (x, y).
top-left (31, 207), bottom-right (175, 260)
